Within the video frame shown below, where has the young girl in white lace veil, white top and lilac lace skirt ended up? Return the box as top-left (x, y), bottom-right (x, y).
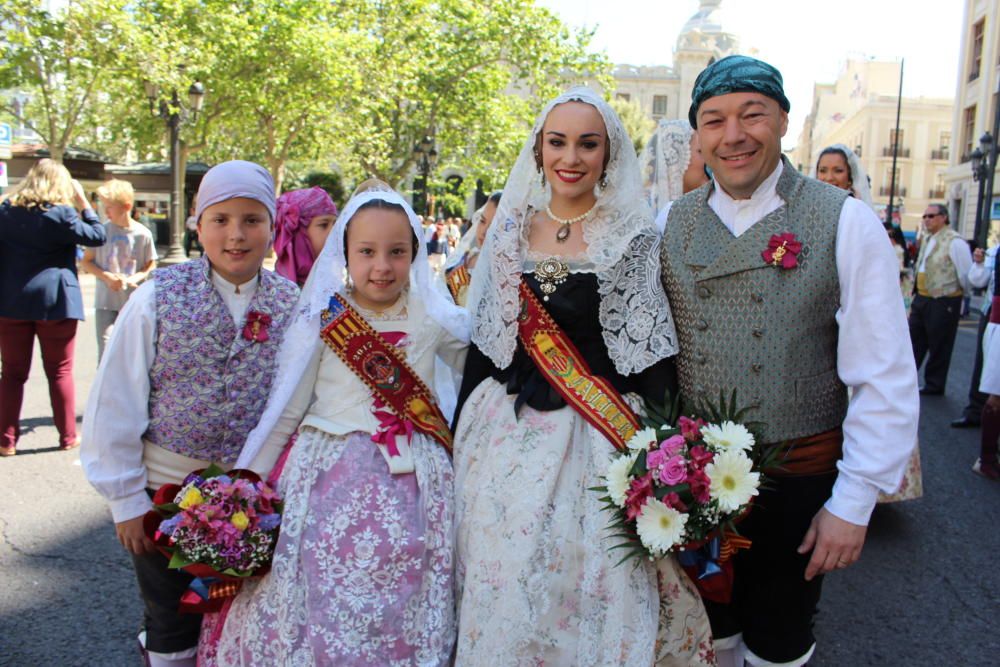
top-left (199, 184), bottom-right (468, 667)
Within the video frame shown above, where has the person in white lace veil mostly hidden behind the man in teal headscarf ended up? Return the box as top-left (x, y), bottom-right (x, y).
top-left (639, 118), bottom-right (709, 233)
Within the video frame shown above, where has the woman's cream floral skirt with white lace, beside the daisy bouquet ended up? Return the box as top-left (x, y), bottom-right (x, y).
top-left (455, 379), bottom-right (715, 667)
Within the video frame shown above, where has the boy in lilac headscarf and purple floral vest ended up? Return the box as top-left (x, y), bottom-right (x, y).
top-left (80, 160), bottom-right (298, 667)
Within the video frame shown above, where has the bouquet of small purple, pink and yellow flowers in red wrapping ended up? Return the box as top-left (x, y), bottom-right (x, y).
top-left (143, 464), bottom-right (282, 613)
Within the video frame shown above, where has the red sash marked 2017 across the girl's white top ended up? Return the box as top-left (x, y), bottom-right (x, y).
top-left (320, 294), bottom-right (451, 454)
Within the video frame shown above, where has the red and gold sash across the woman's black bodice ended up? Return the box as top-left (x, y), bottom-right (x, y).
top-left (517, 280), bottom-right (642, 450)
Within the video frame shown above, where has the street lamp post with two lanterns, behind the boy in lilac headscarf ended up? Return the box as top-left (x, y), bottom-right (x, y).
top-left (145, 81), bottom-right (205, 264)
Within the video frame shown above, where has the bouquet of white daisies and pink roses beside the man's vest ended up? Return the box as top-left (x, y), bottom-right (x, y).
top-left (593, 394), bottom-right (767, 603)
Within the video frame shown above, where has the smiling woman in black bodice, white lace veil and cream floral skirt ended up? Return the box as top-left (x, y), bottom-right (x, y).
top-left (454, 88), bottom-right (711, 667)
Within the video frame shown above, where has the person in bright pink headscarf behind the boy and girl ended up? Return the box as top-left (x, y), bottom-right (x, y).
top-left (274, 187), bottom-right (337, 287)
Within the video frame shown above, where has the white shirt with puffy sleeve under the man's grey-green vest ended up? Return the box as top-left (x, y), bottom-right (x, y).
top-left (657, 164), bottom-right (920, 526)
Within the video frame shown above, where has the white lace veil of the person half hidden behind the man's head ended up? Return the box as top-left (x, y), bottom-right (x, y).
top-left (639, 119), bottom-right (694, 215)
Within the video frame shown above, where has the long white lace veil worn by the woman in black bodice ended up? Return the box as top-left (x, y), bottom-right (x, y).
top-left (469, 87), bottom-right (677, 375)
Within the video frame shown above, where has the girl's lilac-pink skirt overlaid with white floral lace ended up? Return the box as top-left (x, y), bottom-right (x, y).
top-left (205, 427), bottom-right (455, 667)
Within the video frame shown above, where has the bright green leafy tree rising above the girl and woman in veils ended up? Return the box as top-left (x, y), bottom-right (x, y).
top-left (342, 0), bottom-right (608, 187)
